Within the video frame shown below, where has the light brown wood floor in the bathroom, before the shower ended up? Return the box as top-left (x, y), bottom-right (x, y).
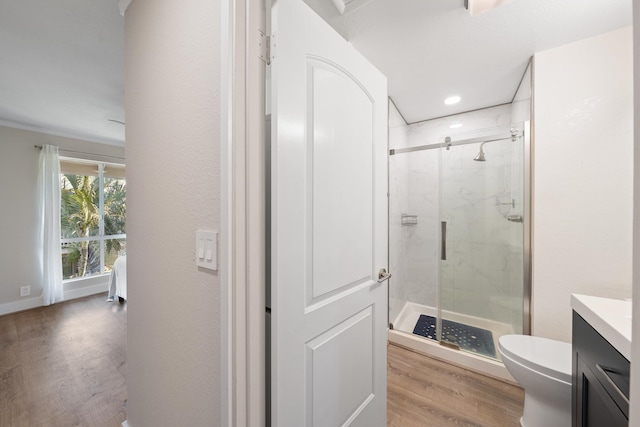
top-left (387, 344), bottom-right (524, 427)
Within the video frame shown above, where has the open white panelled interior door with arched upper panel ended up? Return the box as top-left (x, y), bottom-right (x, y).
top-left (271, 0), bottom-right (388, 427)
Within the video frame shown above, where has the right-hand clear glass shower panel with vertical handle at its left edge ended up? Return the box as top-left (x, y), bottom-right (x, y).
top-left (438, 125), bottom-right (524, 358)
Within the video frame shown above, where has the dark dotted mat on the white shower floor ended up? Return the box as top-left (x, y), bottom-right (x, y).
top-left (413, 314), bottom-right (496, 358)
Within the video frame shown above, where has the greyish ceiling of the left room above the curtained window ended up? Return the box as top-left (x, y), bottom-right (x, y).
top-left (0, 0), bottom-right (124, 145)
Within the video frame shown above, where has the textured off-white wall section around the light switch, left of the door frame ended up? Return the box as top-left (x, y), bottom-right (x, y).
top-left (125, 0), bottom-right (220, 427)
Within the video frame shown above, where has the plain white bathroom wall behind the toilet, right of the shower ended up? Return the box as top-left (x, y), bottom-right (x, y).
top-left (532, 27), bottom-right (633, 341)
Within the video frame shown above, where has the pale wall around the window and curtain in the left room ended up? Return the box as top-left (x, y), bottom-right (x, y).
top-left (0, 126), bottom-right (124, 315)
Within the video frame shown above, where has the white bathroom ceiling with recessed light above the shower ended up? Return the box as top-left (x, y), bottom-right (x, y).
top-left (305, 0), bottom-right (632, 123)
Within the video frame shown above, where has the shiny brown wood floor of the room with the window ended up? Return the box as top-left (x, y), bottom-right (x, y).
top-left (0, 293), bottom-right (127, 427)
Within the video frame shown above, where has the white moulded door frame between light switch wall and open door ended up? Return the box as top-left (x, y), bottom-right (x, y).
top-left (220, 0), bottom-right (267, 427)
